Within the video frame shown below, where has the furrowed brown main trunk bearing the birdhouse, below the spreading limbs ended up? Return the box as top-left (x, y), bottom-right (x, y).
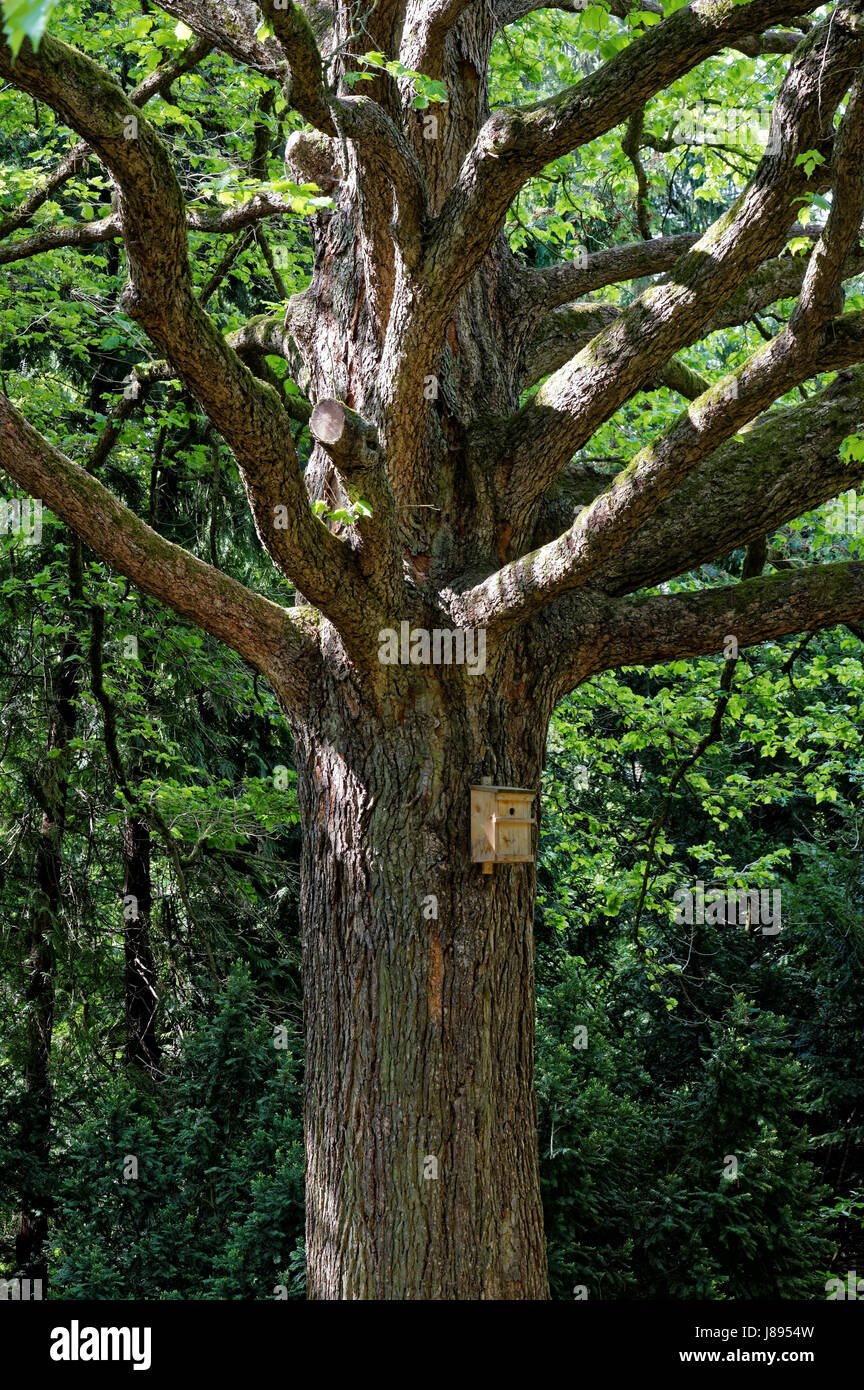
top-left (297, 656), bottom-right (547, 1300)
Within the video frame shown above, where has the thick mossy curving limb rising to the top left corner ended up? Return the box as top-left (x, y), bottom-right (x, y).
top-left (0, 28), bottom-right (375, 634)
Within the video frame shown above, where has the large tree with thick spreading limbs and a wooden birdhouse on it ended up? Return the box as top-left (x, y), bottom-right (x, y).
top-left (0, 0), bottom-right (864, 1298)
